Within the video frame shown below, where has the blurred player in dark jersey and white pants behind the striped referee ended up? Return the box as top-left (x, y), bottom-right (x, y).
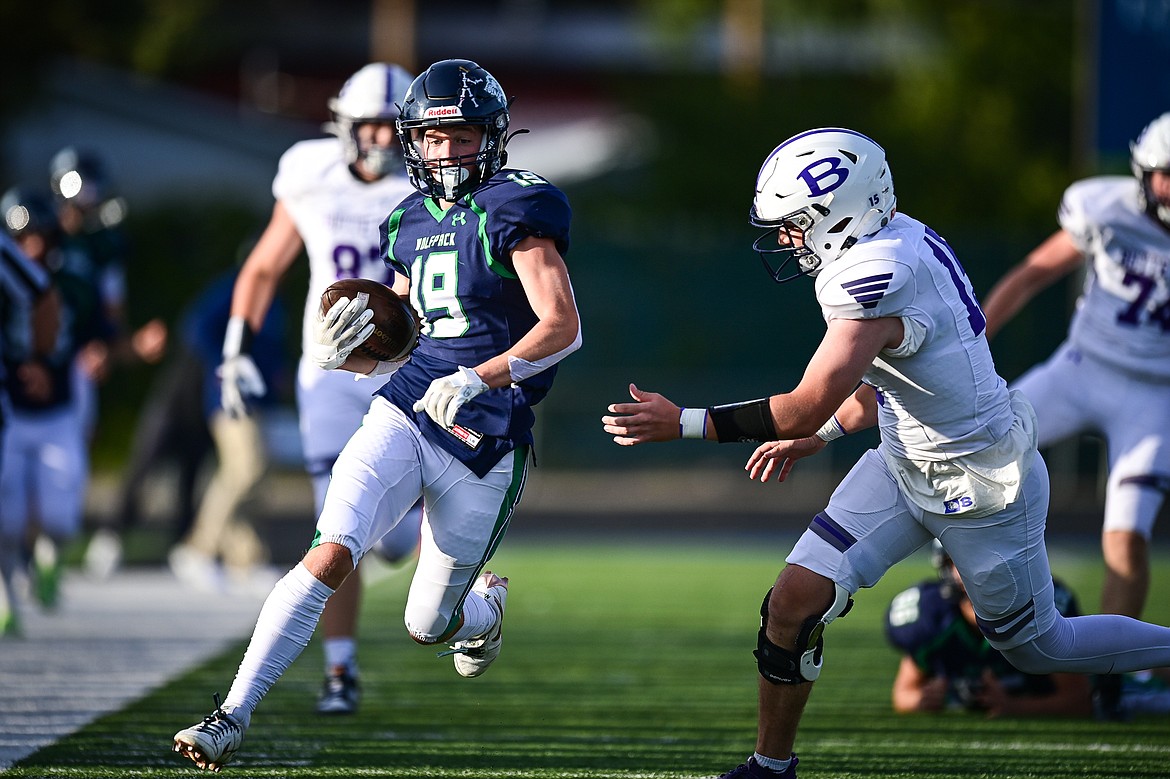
top-left (0, 188), bottom-right (98, 631)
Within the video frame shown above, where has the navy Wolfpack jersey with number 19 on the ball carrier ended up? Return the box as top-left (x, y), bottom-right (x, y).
top-left (378, 170), bottom-right (572, 476)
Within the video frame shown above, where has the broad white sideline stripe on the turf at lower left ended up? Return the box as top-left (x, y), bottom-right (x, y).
top-left (0, 568), bottom-right (264, 772)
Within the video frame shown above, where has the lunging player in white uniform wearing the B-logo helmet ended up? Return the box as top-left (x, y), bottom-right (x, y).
top-left (601, 129), bottom-right (1170, 779)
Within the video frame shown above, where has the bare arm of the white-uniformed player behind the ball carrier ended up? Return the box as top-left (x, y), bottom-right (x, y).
top-left (232, 200), bottom-right (304, 332)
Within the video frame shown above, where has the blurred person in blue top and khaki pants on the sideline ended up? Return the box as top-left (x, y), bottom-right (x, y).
top-left (167, 269), bottom-right (285, 592)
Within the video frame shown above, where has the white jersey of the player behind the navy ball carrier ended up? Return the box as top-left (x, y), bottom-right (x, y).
top-left (273, 138), bottom-right (414, 347)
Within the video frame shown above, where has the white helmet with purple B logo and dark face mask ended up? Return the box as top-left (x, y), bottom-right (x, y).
top-left (751, 127), bottom-right (896, 282)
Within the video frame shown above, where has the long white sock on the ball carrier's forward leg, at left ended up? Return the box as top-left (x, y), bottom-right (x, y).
top-left (223, 563), bottom-right (333, 726)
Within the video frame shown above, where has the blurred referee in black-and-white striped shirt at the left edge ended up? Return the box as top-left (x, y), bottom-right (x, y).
top-left (0, 216), bottom-right (61, 636)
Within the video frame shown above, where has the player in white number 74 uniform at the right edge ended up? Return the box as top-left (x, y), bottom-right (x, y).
top-left (984, 113), bottom-right (1170, 631)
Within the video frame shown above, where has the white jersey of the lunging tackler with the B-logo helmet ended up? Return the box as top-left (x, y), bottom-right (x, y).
top-left (815, 214), bottom-right (1014, 461)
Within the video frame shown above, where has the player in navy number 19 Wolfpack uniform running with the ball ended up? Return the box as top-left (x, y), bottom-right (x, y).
top-left (174, 60), bottom-right (580, 770)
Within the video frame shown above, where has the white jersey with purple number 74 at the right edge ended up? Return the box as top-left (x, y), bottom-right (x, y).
top-left (1059, 175), bottom-right (1170, 381)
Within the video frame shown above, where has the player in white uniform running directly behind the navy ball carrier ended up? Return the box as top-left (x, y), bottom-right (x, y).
top-left (220, 63), bottom-right (422, 713)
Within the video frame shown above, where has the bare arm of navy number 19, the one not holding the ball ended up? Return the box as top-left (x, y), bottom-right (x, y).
top-left (465, 230), bottom-right (580, 387)
